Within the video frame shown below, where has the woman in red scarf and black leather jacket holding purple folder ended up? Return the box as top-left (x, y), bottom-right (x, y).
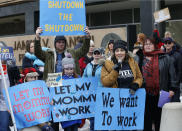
top-left (137, 38), bottom-right (178, 131)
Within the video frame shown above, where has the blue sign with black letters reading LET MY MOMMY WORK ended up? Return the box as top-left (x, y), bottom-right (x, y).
top-left (50, 78), bottom-right (98, 122)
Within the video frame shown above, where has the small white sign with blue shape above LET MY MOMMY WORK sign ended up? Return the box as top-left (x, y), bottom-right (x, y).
top-left (46, 73), bottom-right (62, 87)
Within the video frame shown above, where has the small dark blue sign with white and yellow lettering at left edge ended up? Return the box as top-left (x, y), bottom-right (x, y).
top-left (0, 47), bottom-right (14, 60)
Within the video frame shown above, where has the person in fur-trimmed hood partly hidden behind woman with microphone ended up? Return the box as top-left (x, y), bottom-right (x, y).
top-left (105, 40), bottom-right (114, 60)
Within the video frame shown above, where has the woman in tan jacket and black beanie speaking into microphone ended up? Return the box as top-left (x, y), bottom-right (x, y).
top-left (101, 40), bottom-right (143, 94)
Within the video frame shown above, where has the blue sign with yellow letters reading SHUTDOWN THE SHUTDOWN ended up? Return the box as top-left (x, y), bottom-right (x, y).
top-left (40, 0), bottom-right (86, 36)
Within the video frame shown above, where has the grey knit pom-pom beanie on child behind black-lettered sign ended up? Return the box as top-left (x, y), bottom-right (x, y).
top-left (62, 53), bottom-right (75, 69)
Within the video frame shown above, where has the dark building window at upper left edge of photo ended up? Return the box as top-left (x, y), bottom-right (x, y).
top-left (0, 14), bottom-right (25, 36)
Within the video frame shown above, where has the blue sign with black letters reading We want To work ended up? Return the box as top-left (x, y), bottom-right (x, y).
top-left (94, 88), bottom-right (146, 130)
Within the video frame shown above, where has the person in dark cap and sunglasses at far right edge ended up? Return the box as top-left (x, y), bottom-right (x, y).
top-left (164, 37), bottom-right (182, 102)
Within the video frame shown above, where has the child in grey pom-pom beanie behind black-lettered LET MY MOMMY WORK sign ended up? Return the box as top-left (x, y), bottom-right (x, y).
top-left (61, 53), bottom-right (82, 131)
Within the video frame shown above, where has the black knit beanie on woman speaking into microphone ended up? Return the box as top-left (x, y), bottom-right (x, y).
top-left (113, 40), bottom-right (128, 53)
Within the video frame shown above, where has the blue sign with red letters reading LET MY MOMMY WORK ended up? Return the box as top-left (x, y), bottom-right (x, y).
top-left (4, 80), bottom-right (51, 129)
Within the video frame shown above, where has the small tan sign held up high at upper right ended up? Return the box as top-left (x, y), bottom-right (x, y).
top-left (154, 8), bottom-right (171, 23)
